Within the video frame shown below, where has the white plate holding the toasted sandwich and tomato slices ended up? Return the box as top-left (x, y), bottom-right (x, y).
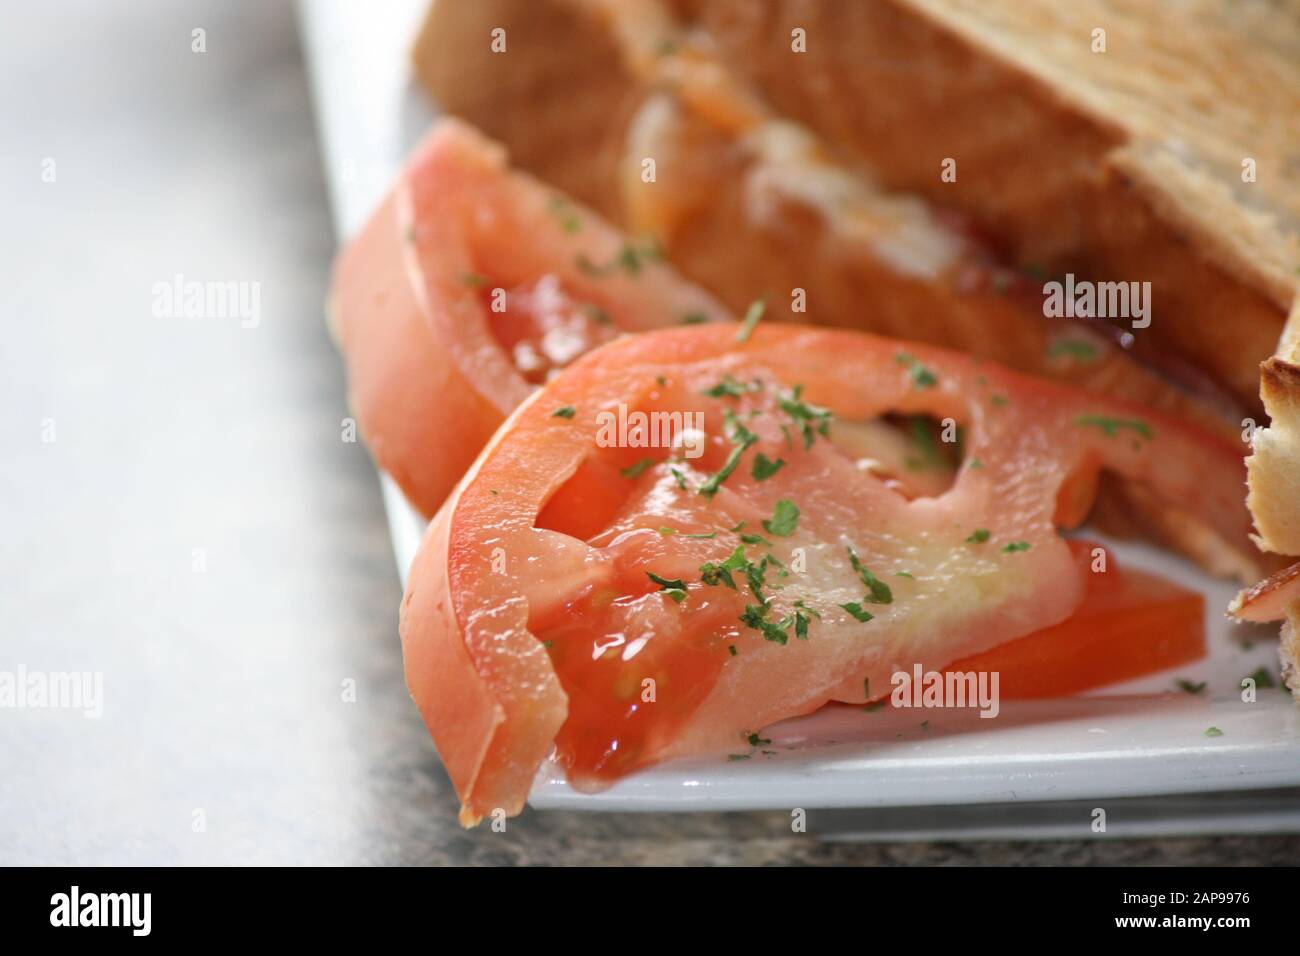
top-left (300, 0), bottom-right (1300, 835)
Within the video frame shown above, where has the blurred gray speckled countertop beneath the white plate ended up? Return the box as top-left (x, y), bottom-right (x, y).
top-left (0, 0), bottom-right (1300, 865)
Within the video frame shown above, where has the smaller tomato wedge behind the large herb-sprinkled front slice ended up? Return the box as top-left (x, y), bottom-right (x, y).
top-left (330, 120), bottom-right (728, 515)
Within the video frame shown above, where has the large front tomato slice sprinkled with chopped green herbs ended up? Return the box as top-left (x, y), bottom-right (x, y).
top-left (402, 325), bottom-right (1249, 823)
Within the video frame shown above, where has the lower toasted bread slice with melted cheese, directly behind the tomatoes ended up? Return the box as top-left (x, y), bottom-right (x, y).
top-left (415, 0), bottom-right (1289, 580)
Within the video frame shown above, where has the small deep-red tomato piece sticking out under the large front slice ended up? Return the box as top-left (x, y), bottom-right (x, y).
top-left (944, 541), bottom-right (1205, 700)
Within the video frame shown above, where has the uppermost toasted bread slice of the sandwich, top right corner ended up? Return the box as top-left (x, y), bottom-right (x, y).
top-left (680, 0), bottom-right (1300, 401)
